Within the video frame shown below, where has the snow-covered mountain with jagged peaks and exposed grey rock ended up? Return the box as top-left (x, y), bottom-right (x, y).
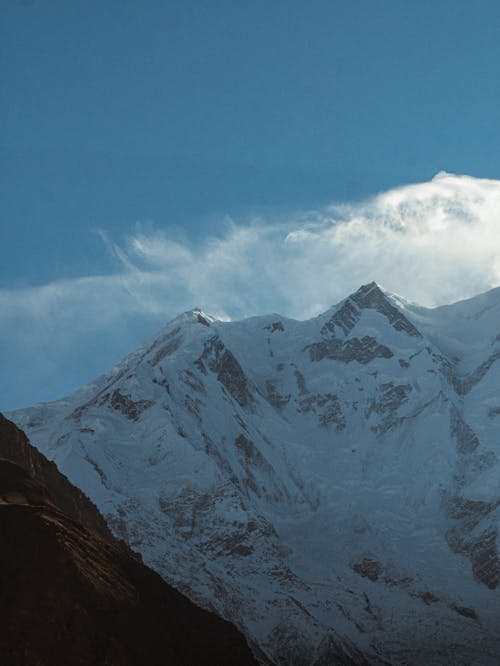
top-left (8, 283), bottom-right (500, 666)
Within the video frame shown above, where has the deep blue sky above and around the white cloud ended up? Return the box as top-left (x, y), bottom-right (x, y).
top-left (0, 0), bottom-right (500, 409)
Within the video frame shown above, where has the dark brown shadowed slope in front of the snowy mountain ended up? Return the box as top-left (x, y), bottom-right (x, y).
top-left (0, 415), bottom-right (256, 666)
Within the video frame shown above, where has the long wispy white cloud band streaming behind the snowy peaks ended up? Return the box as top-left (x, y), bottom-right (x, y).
top-left (0, 173), bottom-right (500, 408)
